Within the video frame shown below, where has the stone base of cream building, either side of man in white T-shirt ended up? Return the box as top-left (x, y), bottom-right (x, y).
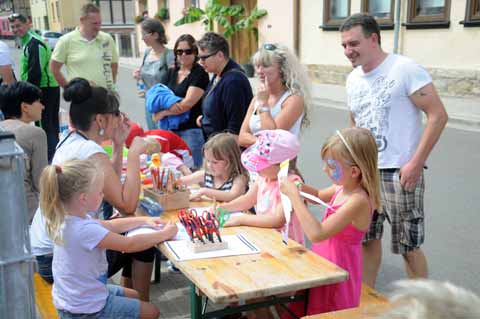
top-left (306, 64), bottom-right (480, 97)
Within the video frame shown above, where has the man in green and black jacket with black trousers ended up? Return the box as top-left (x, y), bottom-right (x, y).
top-left (8, 13), bottom-right (60, 161)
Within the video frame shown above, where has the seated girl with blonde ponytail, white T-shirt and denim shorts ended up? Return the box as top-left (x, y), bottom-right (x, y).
top-left (40, 160), bottom-right (177, 318)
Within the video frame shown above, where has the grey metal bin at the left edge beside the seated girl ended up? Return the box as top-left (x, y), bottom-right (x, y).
top-left (0, 128), bottom-right (35, 319)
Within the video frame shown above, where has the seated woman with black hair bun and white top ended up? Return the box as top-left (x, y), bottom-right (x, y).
top-left (30, 78), bottom-right (155, 300)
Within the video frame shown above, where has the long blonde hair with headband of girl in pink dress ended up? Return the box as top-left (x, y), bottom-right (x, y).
top-left (321, 127), bottom-right (381, 212)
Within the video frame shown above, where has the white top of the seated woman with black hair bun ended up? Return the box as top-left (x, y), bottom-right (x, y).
top-left (30, 132), bottom-right (106, 256)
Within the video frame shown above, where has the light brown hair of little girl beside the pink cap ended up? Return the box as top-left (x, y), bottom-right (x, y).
top-left (203, 133), bottom-right (248, 179)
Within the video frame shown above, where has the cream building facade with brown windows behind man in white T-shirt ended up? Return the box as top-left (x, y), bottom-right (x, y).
top-left (294, 0), bottom-right (480, 96)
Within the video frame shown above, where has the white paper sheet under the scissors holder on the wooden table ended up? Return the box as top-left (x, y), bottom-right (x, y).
top-left (165, 234), bottom-right (260, 261)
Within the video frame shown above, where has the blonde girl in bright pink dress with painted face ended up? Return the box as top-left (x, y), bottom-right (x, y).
top-left (280, 128), bottom-right (381, 316)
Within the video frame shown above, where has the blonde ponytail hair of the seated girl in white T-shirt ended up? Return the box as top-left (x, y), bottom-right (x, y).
top-left (40, 159), bottom-right (102, 244)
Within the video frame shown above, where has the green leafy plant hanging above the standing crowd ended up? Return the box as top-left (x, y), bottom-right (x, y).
top-left (174, 0), bottom-right (267, 39)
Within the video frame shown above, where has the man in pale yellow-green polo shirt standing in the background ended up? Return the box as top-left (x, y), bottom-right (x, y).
top-left (50, 3), bottom-right (118, 89)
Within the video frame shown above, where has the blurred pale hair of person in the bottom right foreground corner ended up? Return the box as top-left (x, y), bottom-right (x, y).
top-left (378, 279), bottom-right (480, 319)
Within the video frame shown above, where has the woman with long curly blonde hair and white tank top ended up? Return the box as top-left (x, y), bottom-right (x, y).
top-left (239, 44), bottom-right (309, 147)
